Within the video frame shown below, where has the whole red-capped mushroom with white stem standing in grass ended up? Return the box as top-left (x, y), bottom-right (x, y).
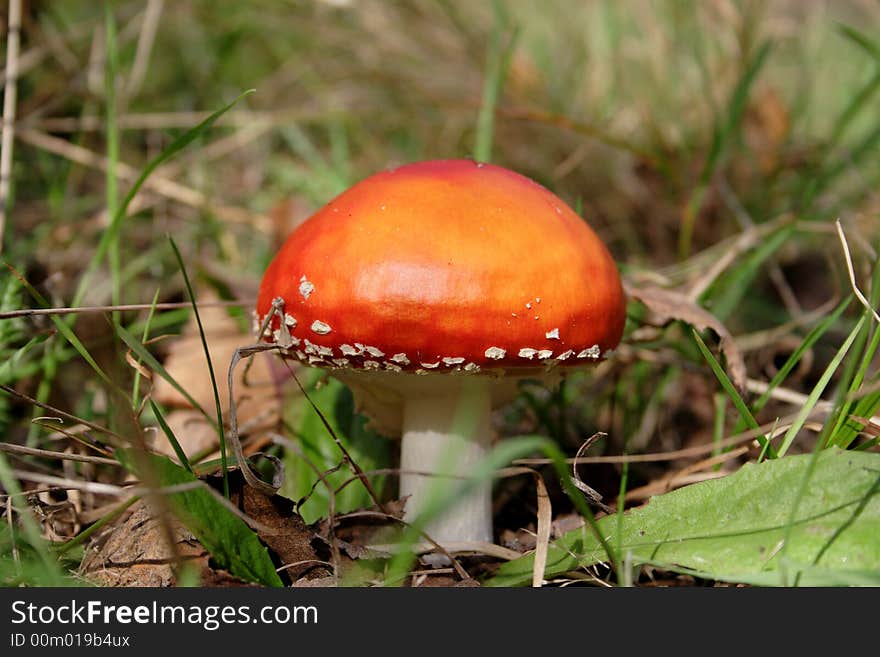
top-left (256, 160), bottom-right (625, 545)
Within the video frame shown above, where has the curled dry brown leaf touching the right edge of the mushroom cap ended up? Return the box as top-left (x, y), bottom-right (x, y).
top-left (624, 283), bottom-right (748, 392)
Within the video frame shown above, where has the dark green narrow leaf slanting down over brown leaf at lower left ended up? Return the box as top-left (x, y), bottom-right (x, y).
top-left (116, 450), bottom-right (282, 586)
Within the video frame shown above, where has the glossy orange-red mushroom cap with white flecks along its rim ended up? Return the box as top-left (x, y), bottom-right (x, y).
top-left (256, 160), bottom-right (626, 373)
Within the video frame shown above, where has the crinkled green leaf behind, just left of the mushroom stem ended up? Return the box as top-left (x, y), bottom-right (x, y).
top-left (279, 377), bottom-right (396, 522)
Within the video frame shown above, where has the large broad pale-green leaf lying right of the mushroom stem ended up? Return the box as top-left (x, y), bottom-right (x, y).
top-left (487, 448), bottom-right (880, 586)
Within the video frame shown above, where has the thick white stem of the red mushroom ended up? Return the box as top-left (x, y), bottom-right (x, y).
top-left (400, 377), bottom-right (492, 545)
